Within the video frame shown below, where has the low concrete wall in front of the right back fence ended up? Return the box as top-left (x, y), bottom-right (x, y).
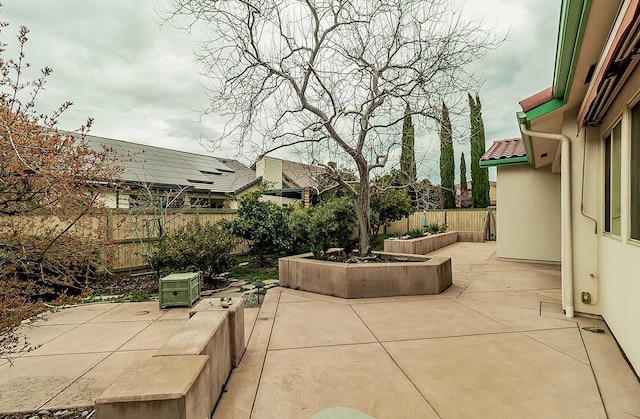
top-left (384, 231), bottom-right (484, 255)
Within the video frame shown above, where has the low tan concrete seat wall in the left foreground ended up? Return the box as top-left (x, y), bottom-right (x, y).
top-left (96, 298), bottom-right (245, 419)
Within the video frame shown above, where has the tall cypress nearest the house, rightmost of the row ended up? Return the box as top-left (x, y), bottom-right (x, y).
top-left (469, 93), bottom-right (490, 208)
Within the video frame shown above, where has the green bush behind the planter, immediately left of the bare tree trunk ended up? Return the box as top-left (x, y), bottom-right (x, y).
top-left (306, 198), bottom-right (357, 259)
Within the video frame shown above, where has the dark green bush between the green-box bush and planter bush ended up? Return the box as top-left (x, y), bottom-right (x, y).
top-left (223, 188), bottom-right (292, 262)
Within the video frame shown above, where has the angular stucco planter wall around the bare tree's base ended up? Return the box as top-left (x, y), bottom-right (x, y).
top-left (279, 252), bottom-right (452, 298)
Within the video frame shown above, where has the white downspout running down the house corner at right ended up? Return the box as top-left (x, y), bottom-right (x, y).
top-left (520, 124), bottom-right (574, 317)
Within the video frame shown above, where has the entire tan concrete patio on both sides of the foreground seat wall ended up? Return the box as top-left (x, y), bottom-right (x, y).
top-left (0, 243), bottom-right (640, 419)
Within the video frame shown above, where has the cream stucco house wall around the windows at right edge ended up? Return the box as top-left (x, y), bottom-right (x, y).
top-left (580, 68), bottom-right (640, 371)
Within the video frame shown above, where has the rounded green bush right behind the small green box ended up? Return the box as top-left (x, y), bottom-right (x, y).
top-left (150, 221), bottom-right (240, 274)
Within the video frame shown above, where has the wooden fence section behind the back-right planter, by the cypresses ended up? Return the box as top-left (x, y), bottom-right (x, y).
top-left (386, 208), bottom-right (497, 240)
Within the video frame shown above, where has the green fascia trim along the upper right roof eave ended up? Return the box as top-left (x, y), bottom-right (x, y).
top-left (552, 0), bottom-right (592, 99)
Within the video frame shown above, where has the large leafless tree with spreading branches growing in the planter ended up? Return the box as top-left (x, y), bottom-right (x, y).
top-left (167, 0), bottom-right (500, 254)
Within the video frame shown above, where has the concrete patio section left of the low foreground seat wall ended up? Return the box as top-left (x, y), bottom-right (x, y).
top-left (0, 302), bottom-right (258, 417)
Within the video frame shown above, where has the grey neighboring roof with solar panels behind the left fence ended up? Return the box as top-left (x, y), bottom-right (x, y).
top-left (86, 135), bottom-right (256, 194)
